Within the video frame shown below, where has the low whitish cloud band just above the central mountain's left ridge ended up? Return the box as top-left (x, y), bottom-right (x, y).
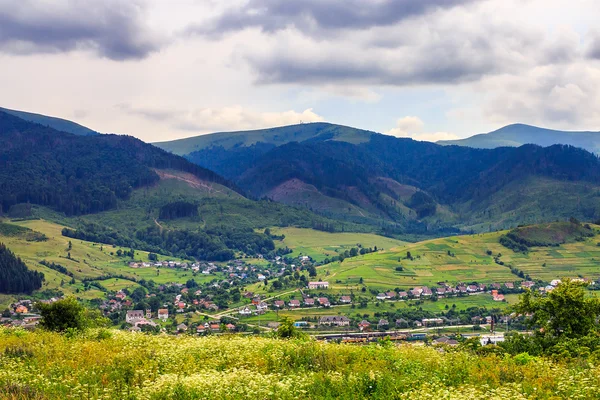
top-left (116, 104), bottom-right (324, 133)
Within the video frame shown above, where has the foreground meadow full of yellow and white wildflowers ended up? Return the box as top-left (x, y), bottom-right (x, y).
top-left (0, 329), bottom-right (600, 400)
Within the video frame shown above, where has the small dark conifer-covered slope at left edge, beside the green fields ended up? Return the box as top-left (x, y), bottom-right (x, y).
top-left (0, 243), bottom-right (44, 293)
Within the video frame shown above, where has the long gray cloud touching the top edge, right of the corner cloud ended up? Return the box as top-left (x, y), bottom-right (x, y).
top-left (189, 0), bottom-right (484, 35)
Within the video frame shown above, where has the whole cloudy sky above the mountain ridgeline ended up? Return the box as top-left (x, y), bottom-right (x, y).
top-left (0, 0), bottom-right (600, 142)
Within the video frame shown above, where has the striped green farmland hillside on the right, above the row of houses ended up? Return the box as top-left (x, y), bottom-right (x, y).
top-left (317, 227), bottom-right (600, 293)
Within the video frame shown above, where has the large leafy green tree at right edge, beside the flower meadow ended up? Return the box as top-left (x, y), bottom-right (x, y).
top-left (514, 280), bottom-right (600, 339)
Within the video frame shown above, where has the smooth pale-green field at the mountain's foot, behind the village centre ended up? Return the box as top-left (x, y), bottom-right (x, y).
top-left (271, 228), bottom-right (407, 261)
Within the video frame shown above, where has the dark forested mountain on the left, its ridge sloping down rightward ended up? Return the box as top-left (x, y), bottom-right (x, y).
top-left (0, 112), bottom-right (235, 215)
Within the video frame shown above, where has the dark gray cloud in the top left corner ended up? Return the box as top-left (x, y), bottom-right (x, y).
top-left (0, 0), bottom-right (164, 61)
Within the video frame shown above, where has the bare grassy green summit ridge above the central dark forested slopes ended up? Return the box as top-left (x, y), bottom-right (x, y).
top-left (154, 122), bottom-right (376, 155)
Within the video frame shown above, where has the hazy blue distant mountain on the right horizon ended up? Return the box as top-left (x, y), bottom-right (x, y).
top-left (437, 124), bottom-right (600, 154)
